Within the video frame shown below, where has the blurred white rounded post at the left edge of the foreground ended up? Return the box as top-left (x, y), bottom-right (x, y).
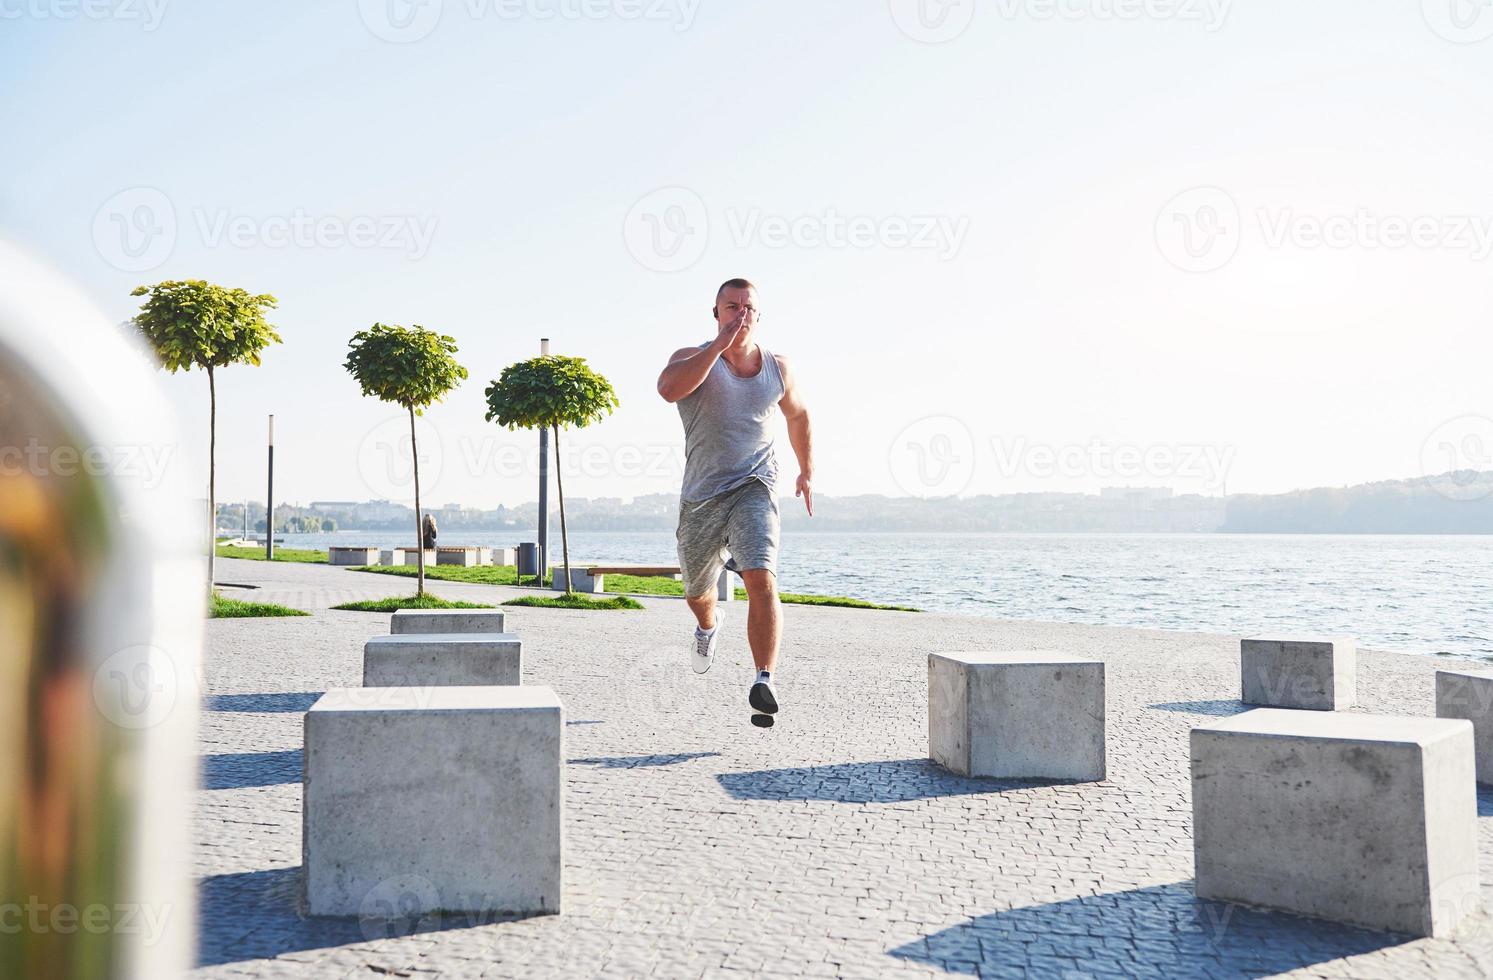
top-left (0, 242), bottom-right (208, 980)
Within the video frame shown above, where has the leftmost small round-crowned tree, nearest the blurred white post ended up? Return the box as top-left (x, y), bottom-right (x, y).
top-left (130, 279), bottom-right (281, 596)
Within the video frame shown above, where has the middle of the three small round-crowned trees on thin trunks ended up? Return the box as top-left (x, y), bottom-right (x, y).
top-left (343, 323), bottom-right (467, 596)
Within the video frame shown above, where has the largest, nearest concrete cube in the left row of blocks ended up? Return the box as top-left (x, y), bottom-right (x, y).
top-left (302, 687), bottom-right (564, 916)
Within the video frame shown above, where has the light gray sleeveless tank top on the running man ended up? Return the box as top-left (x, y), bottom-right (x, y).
top-left (678, 342), bottom-right (784, 502)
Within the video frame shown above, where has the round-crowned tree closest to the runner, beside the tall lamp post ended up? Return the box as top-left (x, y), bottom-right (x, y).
top-left (487, 354), bottom-right (620, 595)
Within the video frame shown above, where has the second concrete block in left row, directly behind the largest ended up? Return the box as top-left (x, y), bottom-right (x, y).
top-left (363, 633), bottom-right (524, 687)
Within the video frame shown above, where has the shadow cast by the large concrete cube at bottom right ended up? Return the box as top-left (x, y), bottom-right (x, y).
top-left (890, 881), bottom-right (1411, 977)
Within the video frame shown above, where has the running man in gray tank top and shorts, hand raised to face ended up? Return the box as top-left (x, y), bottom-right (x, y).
top-left (658, 279), bottom-right (814, 725)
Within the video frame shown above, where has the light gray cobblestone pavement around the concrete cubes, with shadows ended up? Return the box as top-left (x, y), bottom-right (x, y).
top-left (194, 560), bottom-right (1493, 979)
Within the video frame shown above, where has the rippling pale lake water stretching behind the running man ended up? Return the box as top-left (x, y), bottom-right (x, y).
top-left (285, 532), bottom-right (1493, 659)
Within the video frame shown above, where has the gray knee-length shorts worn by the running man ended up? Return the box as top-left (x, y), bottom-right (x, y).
top-left (675, 478), bottom-right (779, 598)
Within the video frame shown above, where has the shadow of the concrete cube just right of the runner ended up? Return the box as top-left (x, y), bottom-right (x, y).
top-left (715, 759), bottom-right (1070, 804)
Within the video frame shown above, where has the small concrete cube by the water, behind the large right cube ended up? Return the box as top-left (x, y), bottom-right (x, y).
top-left (1239, 636), bottom-right (1359, 711)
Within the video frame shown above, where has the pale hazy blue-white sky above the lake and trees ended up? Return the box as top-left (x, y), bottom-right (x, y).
top-left (0, 0), bottom-right (1493, 508)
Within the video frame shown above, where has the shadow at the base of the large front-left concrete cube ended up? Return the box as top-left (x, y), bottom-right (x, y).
top-left (197, 866), bottom-right (524, 977)
